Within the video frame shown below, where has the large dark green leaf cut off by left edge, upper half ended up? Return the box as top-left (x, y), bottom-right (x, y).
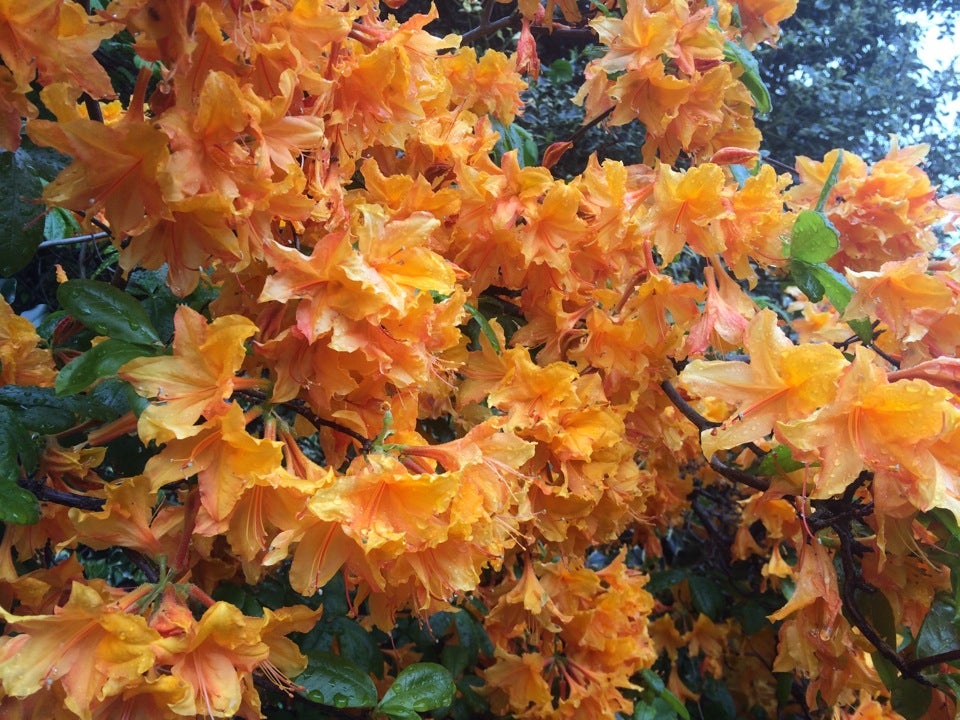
top-left (0, 148), bottom-right (44, 277)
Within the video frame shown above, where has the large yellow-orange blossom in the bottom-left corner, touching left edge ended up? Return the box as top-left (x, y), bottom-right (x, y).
top-left (0, 582), bottom-right (160, 718)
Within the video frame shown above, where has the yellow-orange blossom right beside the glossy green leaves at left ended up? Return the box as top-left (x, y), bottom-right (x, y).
top-left (117, 305), bottom-right (262, 443)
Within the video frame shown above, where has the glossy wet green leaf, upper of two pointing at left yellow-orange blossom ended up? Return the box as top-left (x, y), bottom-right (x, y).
top-left (57, 280), bottom-right (160, 345)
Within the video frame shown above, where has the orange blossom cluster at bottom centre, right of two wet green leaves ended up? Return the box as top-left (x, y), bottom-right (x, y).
top-left (483, 553), bottom-right (656, 720)
